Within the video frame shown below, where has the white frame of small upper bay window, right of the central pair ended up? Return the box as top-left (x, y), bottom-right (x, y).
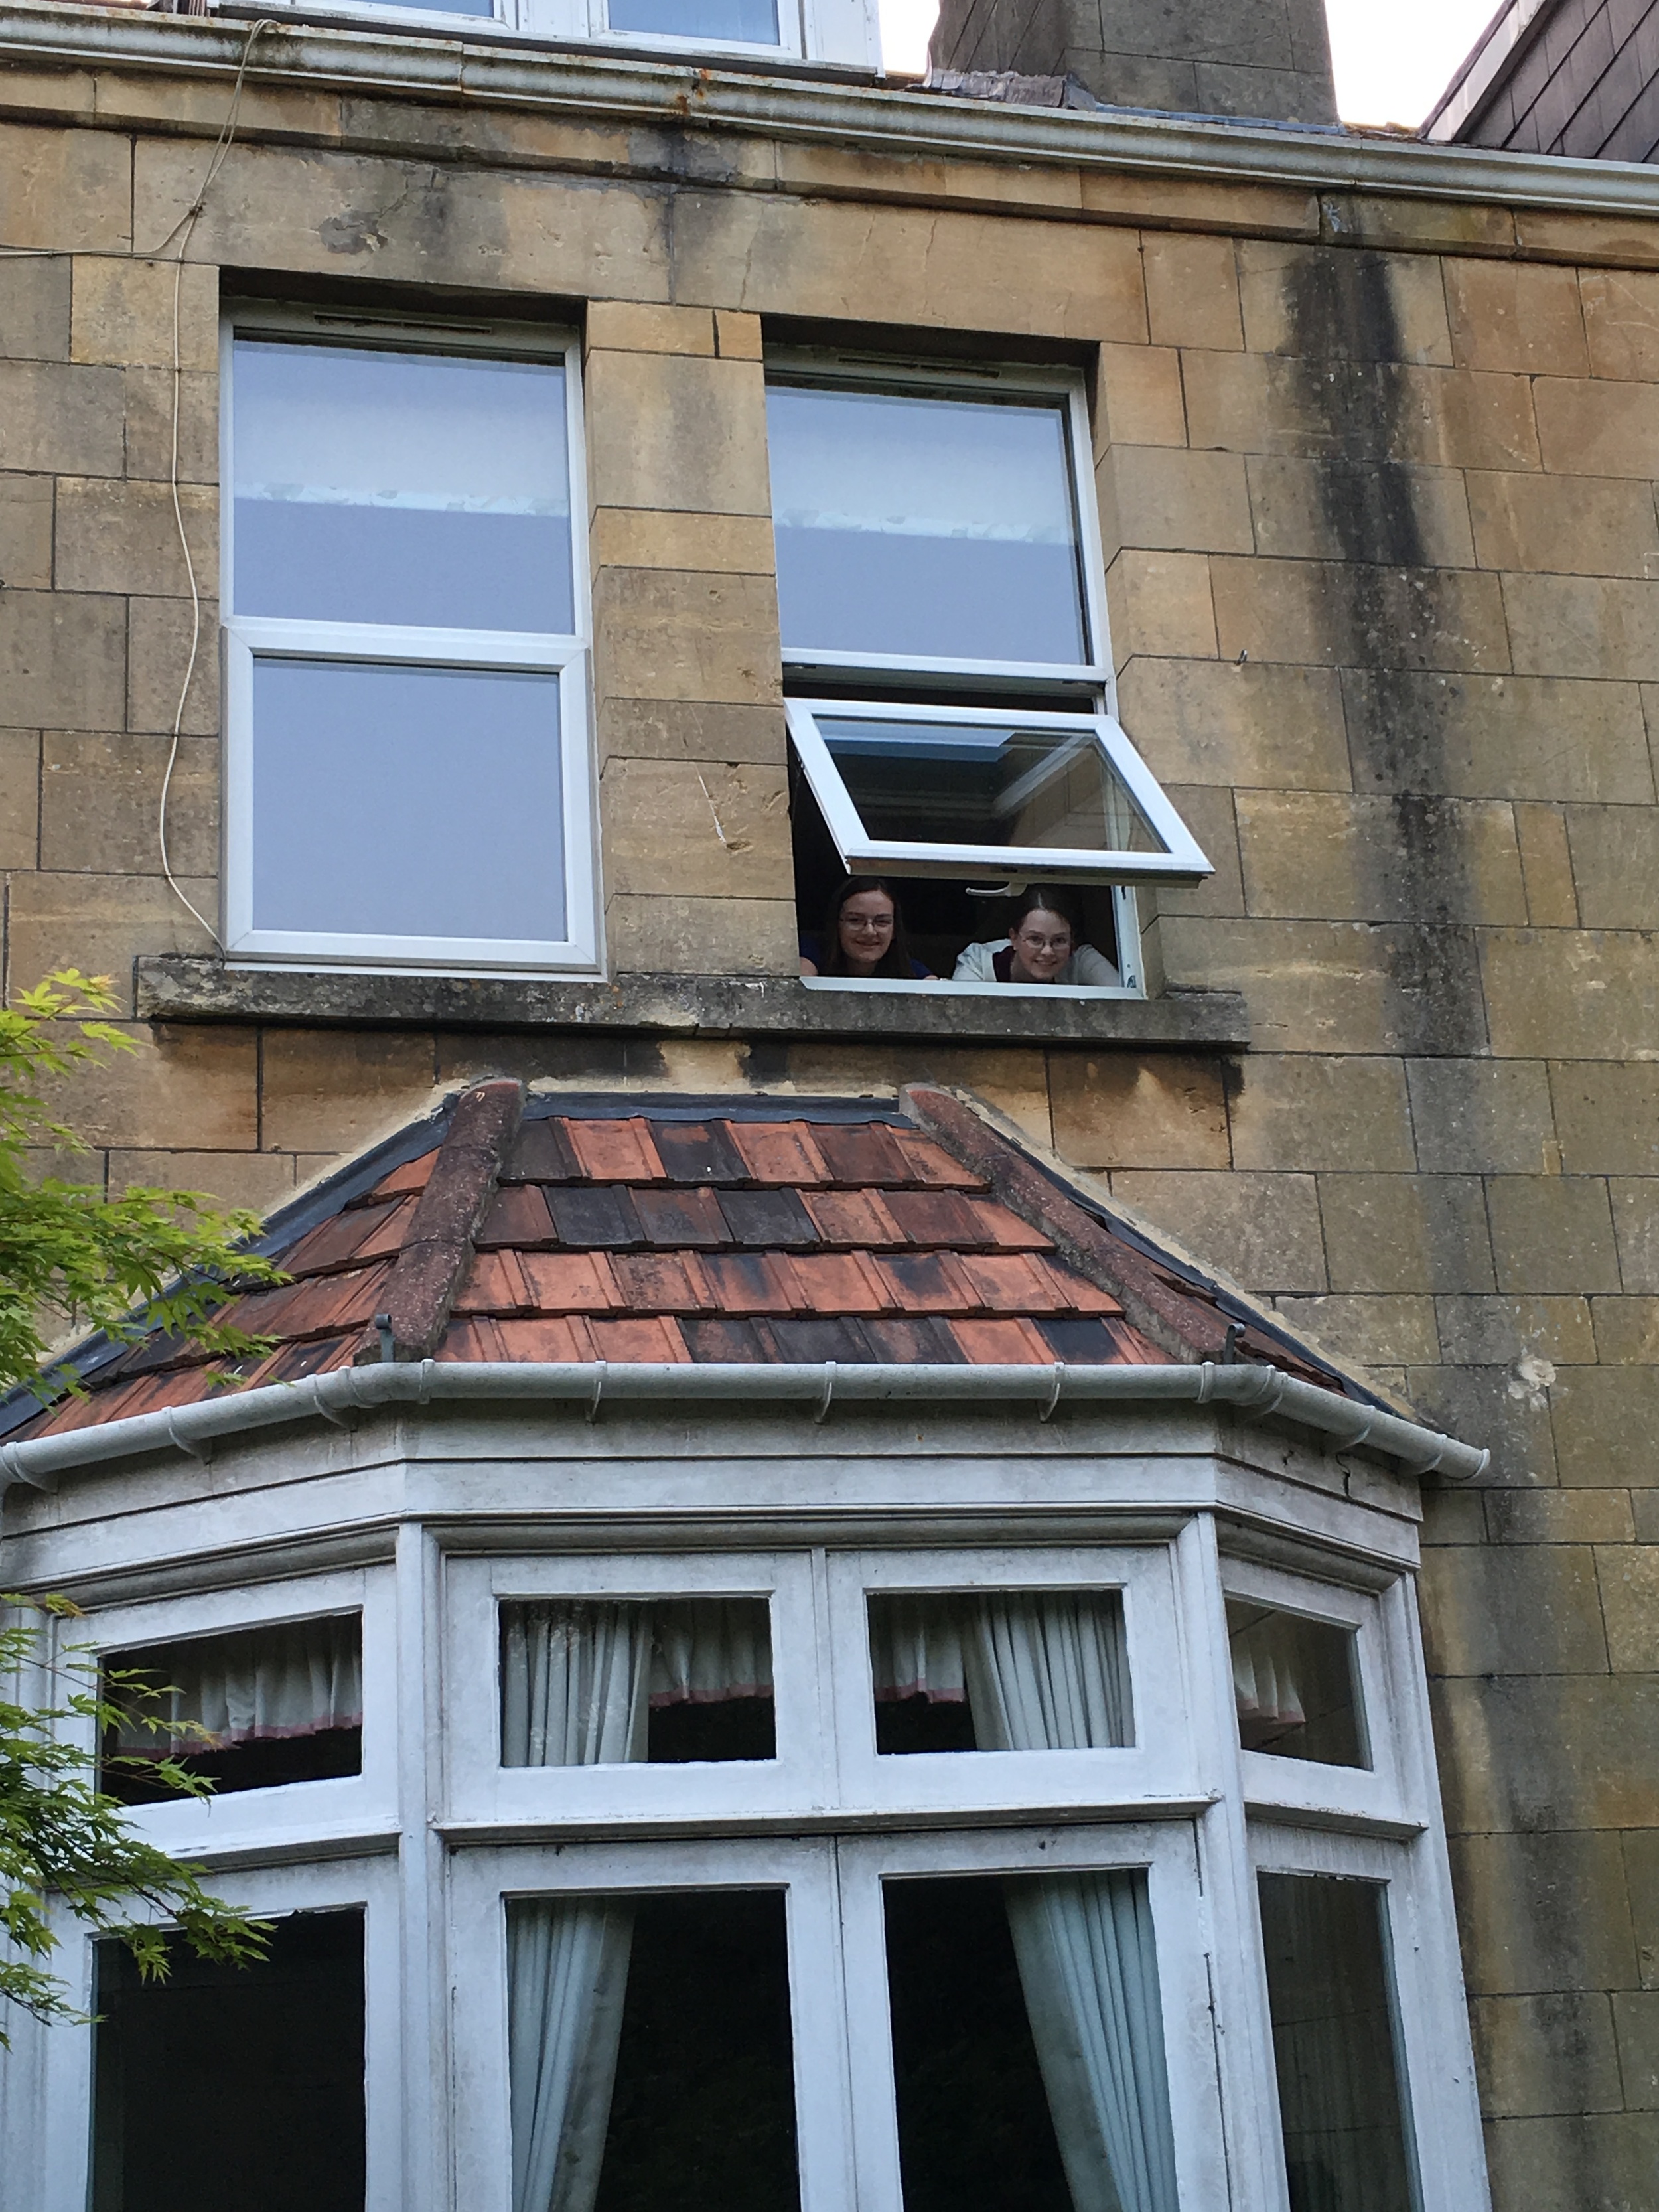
top-left (828, 1544), bottom-right (1203, 1820)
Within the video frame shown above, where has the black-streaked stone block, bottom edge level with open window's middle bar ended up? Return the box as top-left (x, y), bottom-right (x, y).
top-left (1210, 555), bottom-right (1513, 670)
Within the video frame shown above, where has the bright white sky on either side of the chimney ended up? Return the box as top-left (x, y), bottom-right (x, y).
top-left (881, 0), bottom-right (1498, 124)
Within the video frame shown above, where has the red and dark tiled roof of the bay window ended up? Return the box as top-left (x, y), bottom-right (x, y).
top-left (11, 1082), bottom-right (1358, 1436)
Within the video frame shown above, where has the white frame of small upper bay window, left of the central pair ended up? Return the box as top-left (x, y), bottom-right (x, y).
top-left (445, 1553), bottom-right (834, 1827)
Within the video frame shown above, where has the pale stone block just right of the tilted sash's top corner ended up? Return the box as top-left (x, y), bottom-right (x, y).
top-left (1117, 655), bottom-right (1349, 792)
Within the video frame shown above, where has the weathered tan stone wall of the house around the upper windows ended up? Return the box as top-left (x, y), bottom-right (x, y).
top-left (0, 0), bottom-right (1659, 2212)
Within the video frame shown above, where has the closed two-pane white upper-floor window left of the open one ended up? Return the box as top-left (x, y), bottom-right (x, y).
top-left (221, 307), bottom-right (597, 971)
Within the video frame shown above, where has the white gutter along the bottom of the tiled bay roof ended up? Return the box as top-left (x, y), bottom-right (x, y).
top-left (0, 1361), bottom-right (1491, 1491)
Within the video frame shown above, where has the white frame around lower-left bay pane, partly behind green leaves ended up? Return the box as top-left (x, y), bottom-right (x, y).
top-left (40, 1856), bottom-right (409, 2212)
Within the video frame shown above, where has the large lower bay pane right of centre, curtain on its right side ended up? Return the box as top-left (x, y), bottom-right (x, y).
top-left (885, 1872), bottom-right (1177, 2212)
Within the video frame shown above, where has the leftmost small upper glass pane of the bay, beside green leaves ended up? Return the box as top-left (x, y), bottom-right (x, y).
top-left (100, 1613), bottom-right (363, 1805)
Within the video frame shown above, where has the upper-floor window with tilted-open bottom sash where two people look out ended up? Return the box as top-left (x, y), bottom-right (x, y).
top-left (768, 354), bottom-right (1210, 995)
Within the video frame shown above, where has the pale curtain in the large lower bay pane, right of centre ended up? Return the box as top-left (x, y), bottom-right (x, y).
top-left (1004, 1872), bottom-right (1179, 2212)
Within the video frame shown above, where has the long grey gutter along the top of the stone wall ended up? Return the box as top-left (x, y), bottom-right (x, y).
top-left (0, 0), bottom-right (1659, 217)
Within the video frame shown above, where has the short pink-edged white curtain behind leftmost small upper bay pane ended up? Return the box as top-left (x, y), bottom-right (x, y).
top-left (104, 1613), bottom-right (363, 1756)
